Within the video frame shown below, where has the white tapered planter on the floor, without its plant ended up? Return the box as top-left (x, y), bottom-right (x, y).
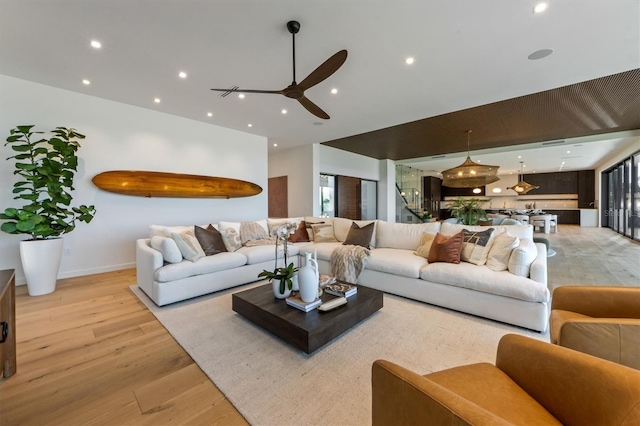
top-left (20, 238), bottom-right (63, 296)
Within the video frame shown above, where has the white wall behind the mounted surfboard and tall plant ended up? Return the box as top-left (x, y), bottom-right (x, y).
top-left (0, 75), bottom-right (267, 283)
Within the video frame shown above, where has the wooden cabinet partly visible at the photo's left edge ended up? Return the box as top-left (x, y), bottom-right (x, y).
top-left (0, 269), bottom-right (16, 381)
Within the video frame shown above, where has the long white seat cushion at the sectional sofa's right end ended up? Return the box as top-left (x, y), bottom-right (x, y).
top-left (420, 262), bottom-right (549, 303)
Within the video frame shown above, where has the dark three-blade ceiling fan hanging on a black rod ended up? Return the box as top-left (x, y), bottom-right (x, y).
top-left (211, 21), bottom-right (347, 120)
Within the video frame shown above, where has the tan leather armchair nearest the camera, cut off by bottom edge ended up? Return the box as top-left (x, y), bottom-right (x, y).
top-left (371, 334), bottom-right (640, 426)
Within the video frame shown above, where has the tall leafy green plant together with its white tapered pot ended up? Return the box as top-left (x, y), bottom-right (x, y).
top-left (0, 125), bottom-right (95, 296)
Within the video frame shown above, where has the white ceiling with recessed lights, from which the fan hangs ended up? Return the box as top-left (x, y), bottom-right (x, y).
top-left (0, 0), bottom-right (640, 172)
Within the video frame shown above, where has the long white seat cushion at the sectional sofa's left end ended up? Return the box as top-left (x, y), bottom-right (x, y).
top-left (153, 252), bottom-right (247, 282)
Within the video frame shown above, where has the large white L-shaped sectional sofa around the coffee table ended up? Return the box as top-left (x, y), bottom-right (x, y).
top-left (136, 218), bottom-right (550, 332)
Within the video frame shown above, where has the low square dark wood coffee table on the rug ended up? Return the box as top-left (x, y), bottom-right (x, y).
top-left (231, 284), bottom-right (383, 354)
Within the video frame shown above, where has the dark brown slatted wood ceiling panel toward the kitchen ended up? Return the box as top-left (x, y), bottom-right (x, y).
top-left (323, 68), bottom-right (640, 160)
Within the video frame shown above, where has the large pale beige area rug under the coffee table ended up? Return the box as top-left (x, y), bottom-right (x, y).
top-left (131, 285), bottom-right (548, 425)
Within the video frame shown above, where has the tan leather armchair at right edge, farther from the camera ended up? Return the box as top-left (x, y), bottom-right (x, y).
top-left (549, 286), bottom-right (640, 368)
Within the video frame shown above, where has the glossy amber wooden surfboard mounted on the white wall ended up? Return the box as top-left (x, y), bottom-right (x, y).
top-left (92, 170), bottom-right (262, 198)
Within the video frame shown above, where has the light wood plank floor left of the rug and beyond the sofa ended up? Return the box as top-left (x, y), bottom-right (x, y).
top-left (0, 225), bottom-right (640, 426)
